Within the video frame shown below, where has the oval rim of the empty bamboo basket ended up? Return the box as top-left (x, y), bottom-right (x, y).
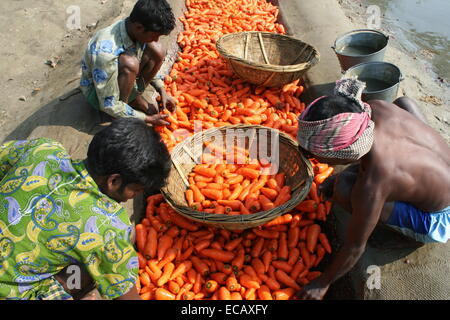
top-left (216, 31), bottom-right (320, 72)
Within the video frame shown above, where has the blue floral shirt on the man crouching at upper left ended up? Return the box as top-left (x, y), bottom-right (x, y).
top-left (80, 20), bottom-right (146, 120)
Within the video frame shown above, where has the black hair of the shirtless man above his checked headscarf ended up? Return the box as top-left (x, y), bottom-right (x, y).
top-left (303, 95), bottom-right (363, 121)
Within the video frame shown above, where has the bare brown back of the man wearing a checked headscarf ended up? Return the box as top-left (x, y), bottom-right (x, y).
top-left (361, 100), bottom-right (450, 212)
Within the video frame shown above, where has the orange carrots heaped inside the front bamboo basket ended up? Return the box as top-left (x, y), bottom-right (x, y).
top-left (185, 144), bottom-right (291, 215)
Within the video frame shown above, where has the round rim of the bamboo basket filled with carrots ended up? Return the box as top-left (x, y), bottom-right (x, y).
top-left (160, 124), bottom-right (314, 229)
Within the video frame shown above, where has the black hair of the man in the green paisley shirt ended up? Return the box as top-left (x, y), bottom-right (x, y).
top-left (87, 118), bottom-right (171, 190)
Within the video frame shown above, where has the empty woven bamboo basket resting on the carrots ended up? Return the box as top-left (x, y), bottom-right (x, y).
top-left (216, 31), bottom-right (320, 87)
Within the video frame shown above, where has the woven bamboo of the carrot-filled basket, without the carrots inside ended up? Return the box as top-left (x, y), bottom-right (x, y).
top-left (161, 125), bottom-right (314, 230)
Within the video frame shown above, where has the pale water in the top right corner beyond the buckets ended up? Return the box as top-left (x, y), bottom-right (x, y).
top-left (361, 0), bottom-right (450, 80)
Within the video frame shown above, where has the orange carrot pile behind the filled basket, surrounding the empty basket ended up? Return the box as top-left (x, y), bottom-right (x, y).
top-left (158, 0), bottom-right (305, 150)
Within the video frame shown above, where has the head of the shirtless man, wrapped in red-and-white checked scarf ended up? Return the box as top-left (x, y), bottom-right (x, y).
top-left (298, 95), bottom-right (374, 165)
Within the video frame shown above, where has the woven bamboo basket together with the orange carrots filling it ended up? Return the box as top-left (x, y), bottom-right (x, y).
top-left (162, 125), bottom-right (314, 230)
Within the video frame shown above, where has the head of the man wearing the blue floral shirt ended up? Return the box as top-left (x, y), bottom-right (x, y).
top-left (129, 0), bottom-right (175, 43)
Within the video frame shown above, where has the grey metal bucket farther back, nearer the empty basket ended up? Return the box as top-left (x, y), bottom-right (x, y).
top-left (331, 29), bottom-right (389, 71)
